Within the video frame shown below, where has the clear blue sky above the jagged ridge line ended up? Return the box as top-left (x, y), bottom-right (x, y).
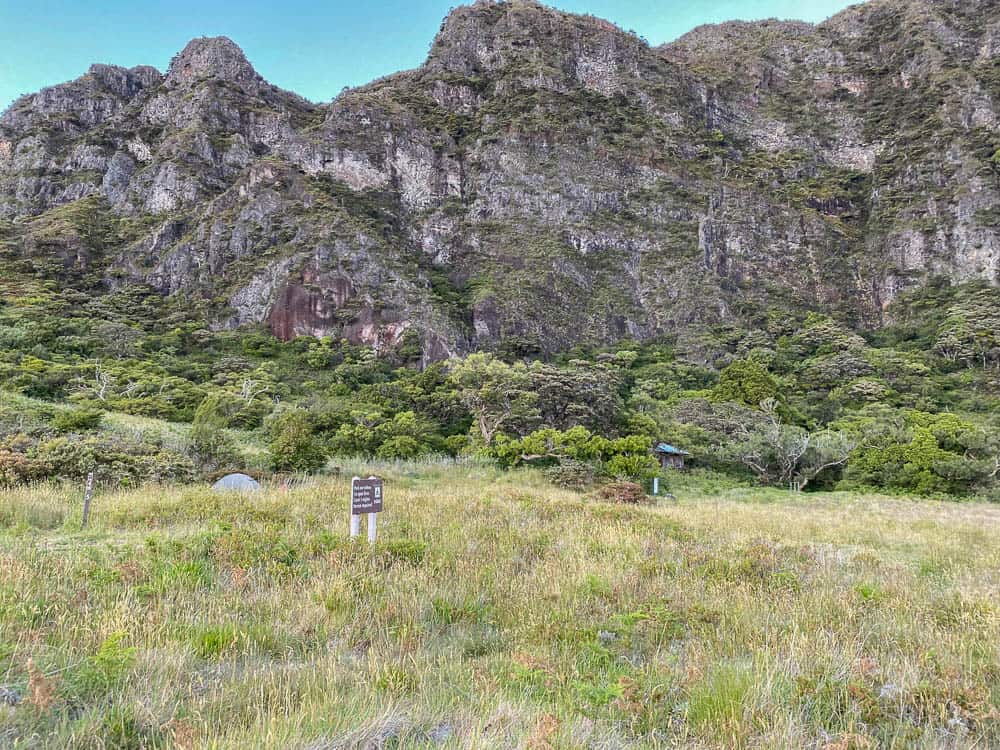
top-left (0, 0), bottom-right (851, 110)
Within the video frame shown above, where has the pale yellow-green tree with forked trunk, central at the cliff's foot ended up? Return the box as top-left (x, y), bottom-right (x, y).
top-left (449, 353), bottom-right (538, 445)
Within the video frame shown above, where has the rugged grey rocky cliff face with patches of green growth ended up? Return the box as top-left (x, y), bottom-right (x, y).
top-left (0, 0), bottom-right (1000, 359)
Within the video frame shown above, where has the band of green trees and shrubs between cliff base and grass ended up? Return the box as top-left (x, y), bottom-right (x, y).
top-left (0, 274), bottom-right (1000, 499)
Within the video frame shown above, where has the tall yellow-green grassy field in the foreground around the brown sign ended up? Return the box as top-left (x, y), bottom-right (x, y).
top-left (0, 465), bottom-right (1000, 750)
